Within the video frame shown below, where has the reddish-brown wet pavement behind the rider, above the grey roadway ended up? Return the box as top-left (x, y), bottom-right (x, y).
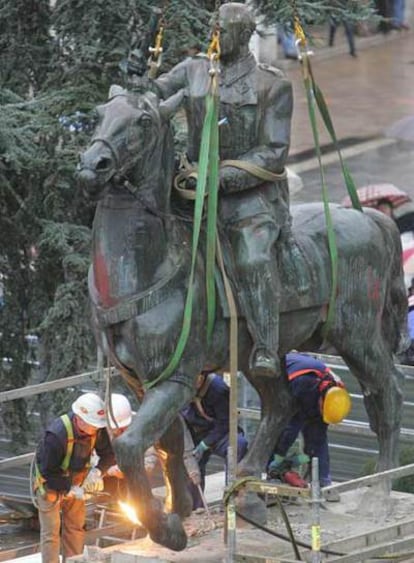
top-left (286, 31), bottom-right (414, 155)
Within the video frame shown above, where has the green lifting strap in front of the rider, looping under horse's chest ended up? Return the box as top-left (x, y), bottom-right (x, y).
top-left (144, 76), bottom-right (219, 391)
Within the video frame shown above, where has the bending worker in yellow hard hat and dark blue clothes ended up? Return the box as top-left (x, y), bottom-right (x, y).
top-left (267, 353), bottom-right (351, 487)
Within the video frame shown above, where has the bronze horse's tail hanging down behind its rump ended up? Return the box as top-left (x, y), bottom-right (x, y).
top-left (369, 211), bottom-right (410, 355)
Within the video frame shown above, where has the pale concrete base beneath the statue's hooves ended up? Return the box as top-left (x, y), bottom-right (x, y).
top-left (68, 487), bottom-right (414, 563)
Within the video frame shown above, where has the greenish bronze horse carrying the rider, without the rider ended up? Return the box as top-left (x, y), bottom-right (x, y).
top-left (77, 91), bottom-right (406, 551)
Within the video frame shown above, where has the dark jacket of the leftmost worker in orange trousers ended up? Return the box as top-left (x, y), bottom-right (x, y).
top-left (36, 411), bottom-right (116, 492)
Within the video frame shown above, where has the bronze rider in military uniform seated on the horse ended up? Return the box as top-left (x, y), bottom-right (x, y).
top-left (147, 2), bottom-right (306, 375)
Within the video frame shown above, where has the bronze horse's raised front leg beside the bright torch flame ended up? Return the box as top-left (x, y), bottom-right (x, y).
top-left (114, 381), bottom-right (193, 551)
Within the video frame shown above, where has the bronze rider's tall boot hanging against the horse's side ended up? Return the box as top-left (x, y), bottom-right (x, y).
top-left (242, 262), bottom-right (280, 377)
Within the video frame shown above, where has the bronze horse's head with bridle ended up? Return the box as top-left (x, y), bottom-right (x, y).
top-left (77, 87), bottom-right (174, 208)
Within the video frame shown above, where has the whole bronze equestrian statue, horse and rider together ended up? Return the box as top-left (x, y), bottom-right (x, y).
top-left (78, 4), bottom-right (406, 550)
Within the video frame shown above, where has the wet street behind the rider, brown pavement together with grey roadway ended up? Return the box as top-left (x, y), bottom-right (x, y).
top-left (274, 23), bottom-right (414, 207)
